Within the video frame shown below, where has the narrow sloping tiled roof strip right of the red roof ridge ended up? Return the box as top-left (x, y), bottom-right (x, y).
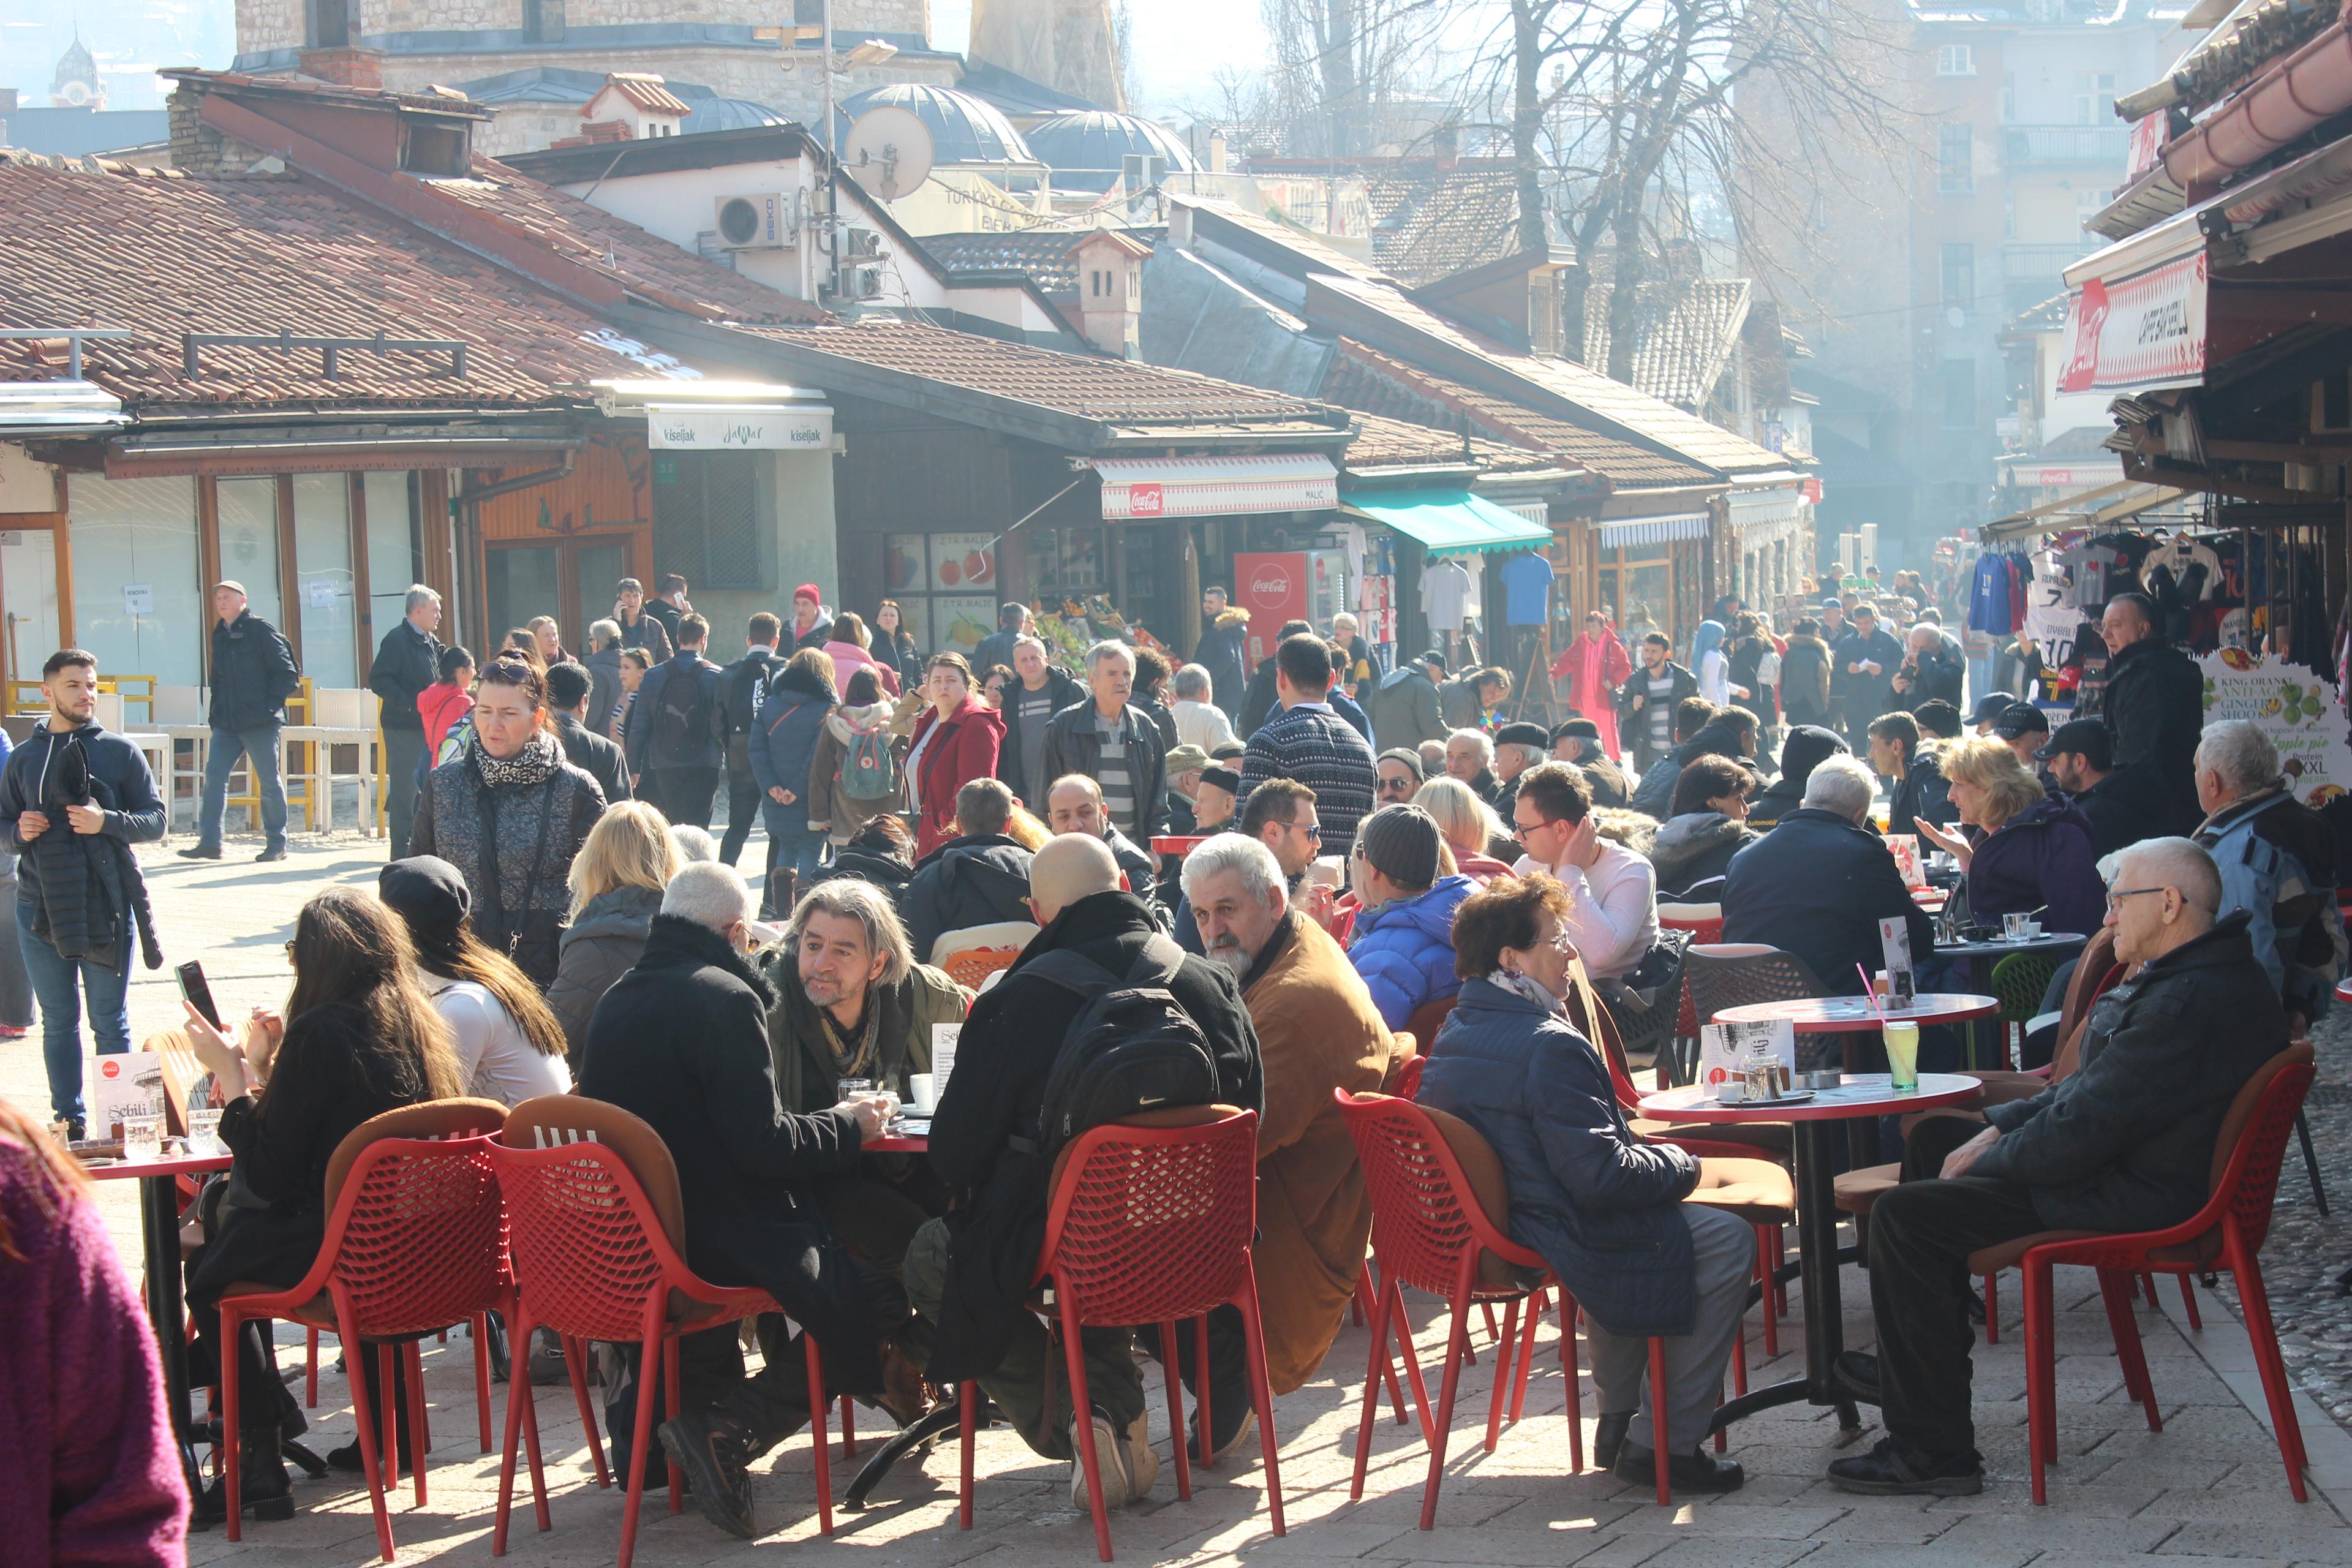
top-left (421, 157), bottom-right (826, 322)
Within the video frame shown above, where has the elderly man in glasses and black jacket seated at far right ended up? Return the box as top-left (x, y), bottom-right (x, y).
top-left (1825, 832), bottom-right (2286, 1498)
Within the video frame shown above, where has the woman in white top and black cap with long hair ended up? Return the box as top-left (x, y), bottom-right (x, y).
top-left (376, 856), bottom-right (571, 1107)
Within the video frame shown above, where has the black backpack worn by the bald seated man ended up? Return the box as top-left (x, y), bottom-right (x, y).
top-left (1021, 933), bottom-right (1218, 1164)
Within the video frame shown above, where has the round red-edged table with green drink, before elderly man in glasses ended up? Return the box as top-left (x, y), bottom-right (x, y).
top-left (1642, 1072), bottom-right (1990, 1431)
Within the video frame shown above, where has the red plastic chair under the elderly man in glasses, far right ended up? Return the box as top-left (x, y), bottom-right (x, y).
top-left (1969, 1041), bottom-right (2315, 1502)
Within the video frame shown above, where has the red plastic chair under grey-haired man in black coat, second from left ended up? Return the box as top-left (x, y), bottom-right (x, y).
top-left (489, 1096), bottom-right (832, 1568)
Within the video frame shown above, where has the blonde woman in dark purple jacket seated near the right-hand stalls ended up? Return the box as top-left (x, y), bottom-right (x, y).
top-left (1912, 736), bottom-right (2108, 936)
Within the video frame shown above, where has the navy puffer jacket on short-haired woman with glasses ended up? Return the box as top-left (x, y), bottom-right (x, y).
top-left (1416, 980), bottom-right (1698, 1335)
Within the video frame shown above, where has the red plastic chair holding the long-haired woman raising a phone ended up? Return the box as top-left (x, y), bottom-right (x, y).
top-left (221, 1100), bottom-right (513, 1563)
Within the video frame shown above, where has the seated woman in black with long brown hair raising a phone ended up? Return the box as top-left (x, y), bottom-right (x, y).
top-left (186, 886), bottom-right (466, 1518)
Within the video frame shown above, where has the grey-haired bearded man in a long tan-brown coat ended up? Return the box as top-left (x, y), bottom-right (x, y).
top-left (1178, 832), bottom-right (1411, 1455)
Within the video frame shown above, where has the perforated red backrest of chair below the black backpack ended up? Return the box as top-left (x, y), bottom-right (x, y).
top-left (1037, 1107), bottom-right (1258, 1326)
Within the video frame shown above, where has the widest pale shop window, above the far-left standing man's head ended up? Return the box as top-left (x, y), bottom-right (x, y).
top-left (68, 475), bottom-right (212, 687)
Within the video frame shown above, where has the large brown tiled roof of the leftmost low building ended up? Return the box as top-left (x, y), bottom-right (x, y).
top-left (0, 155), bottom-right (691, 409)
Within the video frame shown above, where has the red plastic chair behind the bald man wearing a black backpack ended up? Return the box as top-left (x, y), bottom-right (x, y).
top-left (957, 1105), bottom-right (1284, 1563)
